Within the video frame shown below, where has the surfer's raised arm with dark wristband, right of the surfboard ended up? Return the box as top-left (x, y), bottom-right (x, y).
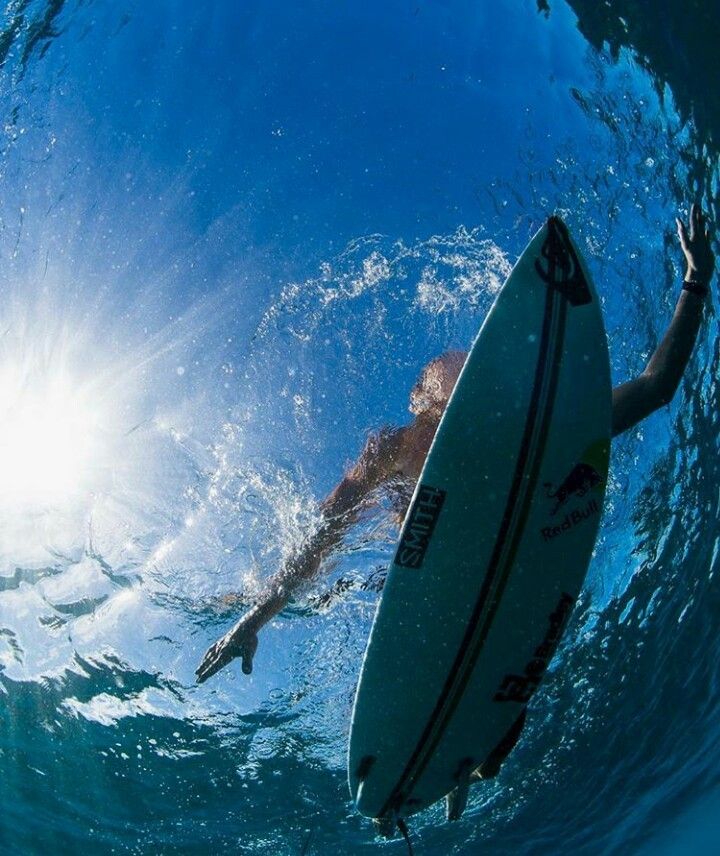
top-left (612, 205), bottom-right (715, 437)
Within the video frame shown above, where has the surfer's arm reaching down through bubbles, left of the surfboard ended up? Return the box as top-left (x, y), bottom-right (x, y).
top-left (195, 430), bottom-right (399, 683)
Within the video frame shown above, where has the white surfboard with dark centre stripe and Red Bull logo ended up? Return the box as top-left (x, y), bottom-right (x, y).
top-left (348, 217), bottom-right (611, 822)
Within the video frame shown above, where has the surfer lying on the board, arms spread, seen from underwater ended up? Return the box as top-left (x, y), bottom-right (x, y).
top-left (196, 205), bottom-right (715, 768)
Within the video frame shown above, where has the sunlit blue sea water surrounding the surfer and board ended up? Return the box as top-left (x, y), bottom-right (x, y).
top-left (0, 0), bottom-right (720, 856)
